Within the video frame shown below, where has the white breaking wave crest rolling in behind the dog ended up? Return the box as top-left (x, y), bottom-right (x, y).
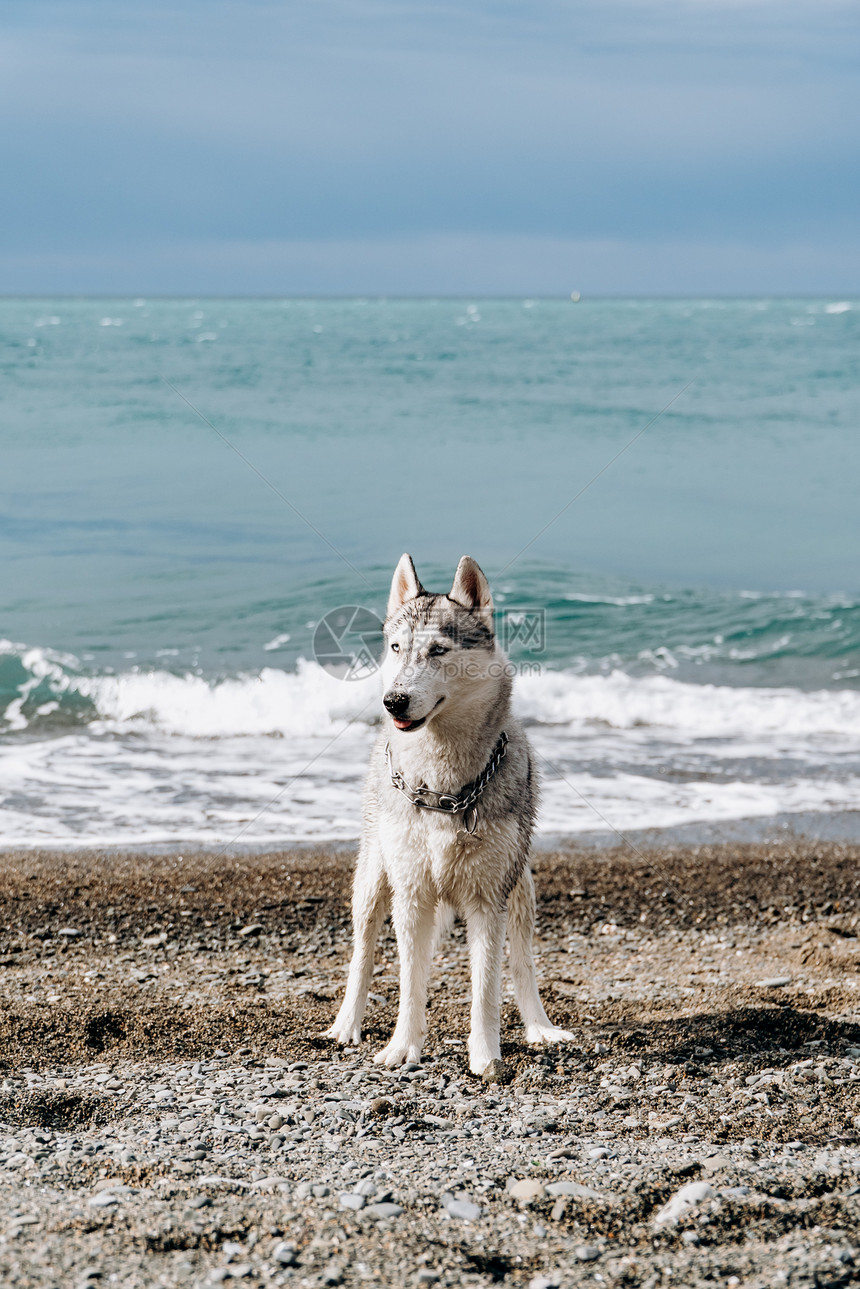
top-left (0, 642), bottom-right (860, 745)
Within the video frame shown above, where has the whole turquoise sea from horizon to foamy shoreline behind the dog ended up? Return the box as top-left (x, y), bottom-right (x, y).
top-left (0, 298), bottom-right (860, 849)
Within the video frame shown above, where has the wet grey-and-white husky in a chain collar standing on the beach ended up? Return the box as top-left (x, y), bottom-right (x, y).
top-left (326, 554), bottom-right (572, 1075)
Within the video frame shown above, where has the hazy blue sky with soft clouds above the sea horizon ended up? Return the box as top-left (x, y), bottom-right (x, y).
top-left (0, 0), bottom-right (860, 295)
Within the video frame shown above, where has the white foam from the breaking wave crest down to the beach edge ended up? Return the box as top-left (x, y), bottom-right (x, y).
top-left (0, 645), bottom-right (860, 846)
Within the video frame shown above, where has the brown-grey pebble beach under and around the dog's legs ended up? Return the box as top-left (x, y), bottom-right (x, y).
top-left (0, 840), bottom-right (860, 1289)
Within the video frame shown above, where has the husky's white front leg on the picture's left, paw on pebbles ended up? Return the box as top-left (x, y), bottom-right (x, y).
top-left (374, 891), bottom-right (436, 1065)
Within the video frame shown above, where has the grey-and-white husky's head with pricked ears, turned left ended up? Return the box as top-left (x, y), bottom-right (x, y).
top-left (382, 556), bottom-right (504, 732)
